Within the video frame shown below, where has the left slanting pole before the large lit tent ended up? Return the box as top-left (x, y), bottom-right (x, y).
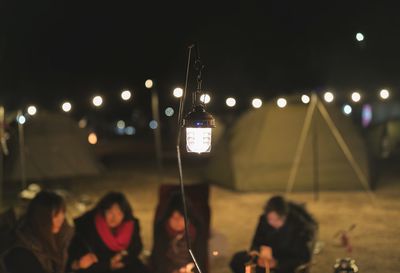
top-left (286, 94), bottom-right (317, 194)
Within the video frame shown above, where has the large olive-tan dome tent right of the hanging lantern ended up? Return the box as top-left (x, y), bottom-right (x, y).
top-left (205, 95), bottom-right (369, 191)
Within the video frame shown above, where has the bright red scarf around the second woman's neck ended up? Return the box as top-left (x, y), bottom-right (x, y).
top-left (95, 214), bottom-right (134, 252)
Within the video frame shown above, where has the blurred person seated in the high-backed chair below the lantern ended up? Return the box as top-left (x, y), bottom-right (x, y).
top-left (151, 194), bottom-right (207, 273)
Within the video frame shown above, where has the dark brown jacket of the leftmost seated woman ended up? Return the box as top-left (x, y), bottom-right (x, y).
top-left (3, 220), bottom-right (73, 273)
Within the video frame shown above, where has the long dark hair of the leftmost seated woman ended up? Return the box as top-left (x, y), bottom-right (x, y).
top-left (26, 191), bottom-right (66, 253)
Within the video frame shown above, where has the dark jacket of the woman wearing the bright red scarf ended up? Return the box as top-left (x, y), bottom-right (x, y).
top-left (69, 210), bottom-right (143, 273)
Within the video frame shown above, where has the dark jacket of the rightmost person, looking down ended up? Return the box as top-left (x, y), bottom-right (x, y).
top-left (251, 203), bottom-right (317, 273)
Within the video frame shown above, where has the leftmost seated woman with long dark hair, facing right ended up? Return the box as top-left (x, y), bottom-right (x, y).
top-left (3, 191), bottom-right (73, 273)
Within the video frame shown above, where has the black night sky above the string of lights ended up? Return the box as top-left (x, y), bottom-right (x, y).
top-left (0, 0), bottom-right (400, 113)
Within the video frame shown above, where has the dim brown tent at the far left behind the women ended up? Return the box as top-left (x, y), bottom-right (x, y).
top-left (5, 111), bottom-right (101, 181)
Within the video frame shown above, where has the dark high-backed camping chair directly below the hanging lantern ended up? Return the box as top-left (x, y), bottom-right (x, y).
top-left (153, 184), bottom-right (211, 273)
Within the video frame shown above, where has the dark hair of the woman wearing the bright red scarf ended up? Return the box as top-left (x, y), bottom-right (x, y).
top-left (96, 191), bottom-right (133, 221)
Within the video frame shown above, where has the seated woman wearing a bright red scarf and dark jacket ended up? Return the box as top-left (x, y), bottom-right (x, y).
top-left (69, 192), bottom-right (146, 273)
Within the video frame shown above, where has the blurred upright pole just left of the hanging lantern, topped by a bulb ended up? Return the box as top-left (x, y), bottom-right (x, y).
top-left (151, 88), bottom-right (164, 183)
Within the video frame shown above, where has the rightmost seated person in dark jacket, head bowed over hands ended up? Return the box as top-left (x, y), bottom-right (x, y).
top-left (230, 196), bottom-right (318, 273)
